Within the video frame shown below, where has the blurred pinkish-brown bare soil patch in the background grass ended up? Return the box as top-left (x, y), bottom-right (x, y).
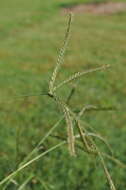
top-left (63, 2), bottom-right (126, 14)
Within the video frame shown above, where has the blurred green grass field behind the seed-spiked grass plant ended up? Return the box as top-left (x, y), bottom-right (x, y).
top-left (0, 0), bottom-right (126, 190)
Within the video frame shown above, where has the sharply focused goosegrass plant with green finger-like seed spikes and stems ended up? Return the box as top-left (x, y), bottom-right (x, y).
top-left (0, 13), bottom-right (126, 190)
